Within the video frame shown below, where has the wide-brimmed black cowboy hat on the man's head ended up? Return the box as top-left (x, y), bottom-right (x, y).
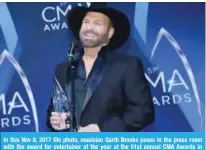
top-left (68, 2), bottom-right (130, 49)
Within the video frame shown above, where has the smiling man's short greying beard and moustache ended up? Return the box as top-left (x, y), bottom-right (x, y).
top-left (80, 31), bottom-right (108, 48)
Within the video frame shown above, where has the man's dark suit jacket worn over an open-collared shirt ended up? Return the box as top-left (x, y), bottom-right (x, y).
top-left (48, 52), bottom-right (154, 132)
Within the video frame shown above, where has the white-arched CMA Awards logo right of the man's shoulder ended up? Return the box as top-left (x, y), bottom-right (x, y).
top-left (145, 28), bottom-right (203, 124)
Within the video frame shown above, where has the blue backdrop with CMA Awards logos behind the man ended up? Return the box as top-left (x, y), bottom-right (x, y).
top-left (0, 2), bottom-right (205, 132)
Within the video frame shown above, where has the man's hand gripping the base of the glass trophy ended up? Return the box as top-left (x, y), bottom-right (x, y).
top-left (50, 112), bottom-right (69, 130)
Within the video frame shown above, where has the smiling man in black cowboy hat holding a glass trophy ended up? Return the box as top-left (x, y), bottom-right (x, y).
top-left (49, 3), bottom-right (154, 132)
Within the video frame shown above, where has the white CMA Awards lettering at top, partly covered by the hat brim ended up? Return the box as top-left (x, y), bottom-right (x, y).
top-left (41, 2), bottom-right (90, 32)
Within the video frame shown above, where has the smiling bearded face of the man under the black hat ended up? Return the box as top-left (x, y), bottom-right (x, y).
top-left (79, 12), bottom-right (114, 48)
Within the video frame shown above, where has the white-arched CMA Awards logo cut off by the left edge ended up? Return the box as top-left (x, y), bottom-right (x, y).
top-left (0, 50), bottom-right (39, 132)
